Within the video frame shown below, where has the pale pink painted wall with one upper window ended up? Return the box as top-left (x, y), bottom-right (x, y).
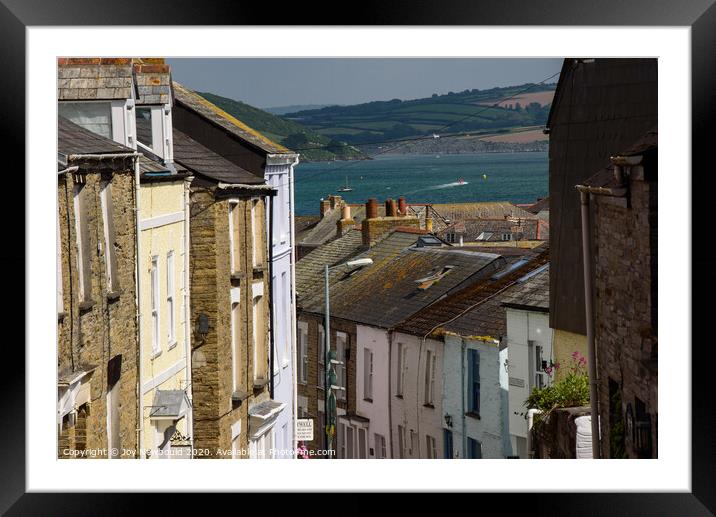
top-left (356, 325), bottom-right (391, 459)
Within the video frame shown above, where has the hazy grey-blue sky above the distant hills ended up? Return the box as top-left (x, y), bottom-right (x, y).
top-left (167, 58), bottom-right (562, 108)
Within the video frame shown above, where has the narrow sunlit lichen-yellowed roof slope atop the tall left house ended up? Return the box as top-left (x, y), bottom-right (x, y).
top-left (172, 81), bottom-right (293, 154)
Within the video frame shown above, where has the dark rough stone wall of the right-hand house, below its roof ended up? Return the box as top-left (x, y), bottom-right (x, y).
top-left (593, 171), bottom-right (658, 458)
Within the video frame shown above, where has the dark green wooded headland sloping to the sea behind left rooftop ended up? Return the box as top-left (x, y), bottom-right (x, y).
top-left (197, 92), bottom-right (367, 161)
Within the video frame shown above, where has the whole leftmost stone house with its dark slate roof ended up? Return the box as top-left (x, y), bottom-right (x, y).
top-left (57, 117), bottom-right (138, 459)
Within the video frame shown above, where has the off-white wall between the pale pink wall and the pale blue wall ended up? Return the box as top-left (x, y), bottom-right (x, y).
top-left (390, 332), bottom-right (443, 458)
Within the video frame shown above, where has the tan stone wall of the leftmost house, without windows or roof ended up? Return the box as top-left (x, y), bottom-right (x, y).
top-left (57, 160), bottom-right (138, 458)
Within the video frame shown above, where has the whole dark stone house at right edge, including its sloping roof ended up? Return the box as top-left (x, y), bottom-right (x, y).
top-left (578, 130), bottom-right (658, 458)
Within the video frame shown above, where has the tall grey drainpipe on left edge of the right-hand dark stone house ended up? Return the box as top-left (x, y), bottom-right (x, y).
top-left (579, 191), bottom-right (600, 459)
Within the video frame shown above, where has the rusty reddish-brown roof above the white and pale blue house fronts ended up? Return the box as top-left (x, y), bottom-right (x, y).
top-left (397, 245), bottom-right (549, 340)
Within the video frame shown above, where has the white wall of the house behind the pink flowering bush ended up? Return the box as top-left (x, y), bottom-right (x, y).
top-left (506, 308), bottom-right (553, 458)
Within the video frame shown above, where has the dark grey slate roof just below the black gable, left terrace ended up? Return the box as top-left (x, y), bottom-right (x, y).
top-left (173, 128), bottom-right (265, 185)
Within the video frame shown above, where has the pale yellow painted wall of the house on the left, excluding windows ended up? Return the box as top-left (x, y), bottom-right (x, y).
top-left (139, 180), bottom-right (188, 457)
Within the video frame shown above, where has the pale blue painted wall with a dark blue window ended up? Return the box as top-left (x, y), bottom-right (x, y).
top-left (443, 335), bottom-right (511, 458)
